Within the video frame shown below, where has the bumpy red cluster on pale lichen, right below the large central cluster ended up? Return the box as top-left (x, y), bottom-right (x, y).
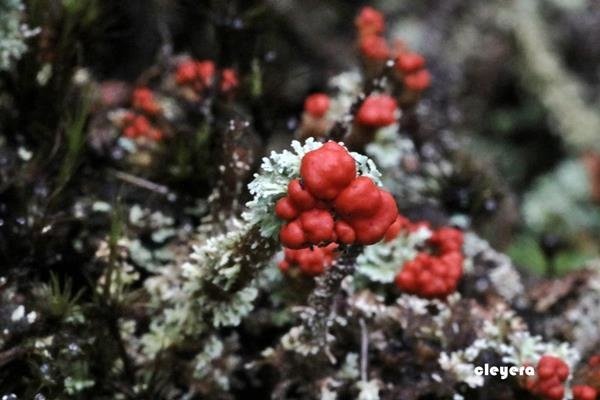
top-left (395, 227), bottom-right (464, 298)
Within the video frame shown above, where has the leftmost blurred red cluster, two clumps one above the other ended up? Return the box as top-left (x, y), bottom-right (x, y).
top-left (122, 87), bottom-right (164, 141)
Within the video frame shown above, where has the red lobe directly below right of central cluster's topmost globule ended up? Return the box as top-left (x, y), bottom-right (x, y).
top-left (334, 176), bottom-right (381, 219)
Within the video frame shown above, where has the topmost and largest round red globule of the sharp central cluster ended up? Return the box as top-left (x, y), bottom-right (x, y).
top-left (300, 142), bottom-right (356, 200)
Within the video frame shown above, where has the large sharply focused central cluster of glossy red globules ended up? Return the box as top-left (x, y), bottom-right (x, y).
top-left (275, 141), bottom-right (398, 249)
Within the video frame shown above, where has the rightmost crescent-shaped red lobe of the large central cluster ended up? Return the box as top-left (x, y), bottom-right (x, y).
top-left (348, 190), bottom-right (398, 245)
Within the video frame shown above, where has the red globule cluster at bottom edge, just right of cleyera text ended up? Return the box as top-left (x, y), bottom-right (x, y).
top-left (527, 355), bottom-right (569, 400)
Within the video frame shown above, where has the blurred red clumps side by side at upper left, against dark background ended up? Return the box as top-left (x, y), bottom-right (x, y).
top-left (175, 60), bottom-right (239, 94)
